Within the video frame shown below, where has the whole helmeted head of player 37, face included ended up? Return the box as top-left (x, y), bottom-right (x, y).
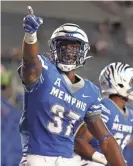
top-left (49, 23), bottom-right (90, 72)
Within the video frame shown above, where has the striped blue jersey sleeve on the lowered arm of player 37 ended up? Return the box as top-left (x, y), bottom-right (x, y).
top-left (85, 97), bottom-right (110, 121)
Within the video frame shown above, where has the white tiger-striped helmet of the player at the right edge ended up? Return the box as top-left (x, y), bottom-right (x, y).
top-left (99, 62), bottom-right (133, 100)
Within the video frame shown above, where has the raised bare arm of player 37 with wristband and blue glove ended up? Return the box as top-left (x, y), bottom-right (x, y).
top-left (21, 6), bottom-right (43, 85)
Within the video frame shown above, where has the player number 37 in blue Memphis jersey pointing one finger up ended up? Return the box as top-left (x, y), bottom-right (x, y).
top-left (18, 7), bottom-right (125, 166)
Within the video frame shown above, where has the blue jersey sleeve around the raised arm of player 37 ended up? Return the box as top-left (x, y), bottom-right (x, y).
top-left (18, 55), bottom-right (50, 93)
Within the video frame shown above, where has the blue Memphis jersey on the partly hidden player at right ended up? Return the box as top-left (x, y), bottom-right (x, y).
top-left (91, 98), bottom-right (133, 152)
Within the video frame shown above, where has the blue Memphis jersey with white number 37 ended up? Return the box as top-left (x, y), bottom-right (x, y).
top-left (18, 55), bottom-right (104, 158)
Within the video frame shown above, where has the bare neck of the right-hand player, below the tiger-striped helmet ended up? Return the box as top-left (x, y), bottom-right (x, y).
top-left (110, 95), bottom-right (126, 110)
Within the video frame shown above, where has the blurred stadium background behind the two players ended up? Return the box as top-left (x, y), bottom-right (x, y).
top-left (1, 1), bottom-right (133, 166)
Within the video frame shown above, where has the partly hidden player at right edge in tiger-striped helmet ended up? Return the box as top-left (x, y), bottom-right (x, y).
top-left (75, 62), bottom-right (133, 166)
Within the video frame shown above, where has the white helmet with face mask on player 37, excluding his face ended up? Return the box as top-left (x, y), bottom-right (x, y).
top-left (49, 23), bottom-right (90, 72)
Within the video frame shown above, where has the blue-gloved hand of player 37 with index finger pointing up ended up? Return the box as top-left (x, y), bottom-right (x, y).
top-left (23, 6), bottom-right (43, 34)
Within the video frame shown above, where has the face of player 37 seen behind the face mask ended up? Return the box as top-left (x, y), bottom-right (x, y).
top-left (57, 41), bottom-right (81, 65)
